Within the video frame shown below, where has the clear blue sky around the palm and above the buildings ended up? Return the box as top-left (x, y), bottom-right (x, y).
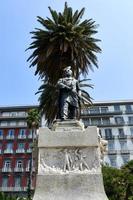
top-left (0, 0), bottom-right (133, 105)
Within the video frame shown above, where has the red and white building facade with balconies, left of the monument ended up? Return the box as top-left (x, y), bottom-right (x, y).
top-left (0, 106), bottom-right (37, 193)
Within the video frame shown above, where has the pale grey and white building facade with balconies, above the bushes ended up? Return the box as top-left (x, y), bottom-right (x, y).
top-left (82, 101), bottom-right (133, 168)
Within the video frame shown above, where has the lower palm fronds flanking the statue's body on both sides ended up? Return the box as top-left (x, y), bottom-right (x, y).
top-left (36, 79), bottom-right (93, 124)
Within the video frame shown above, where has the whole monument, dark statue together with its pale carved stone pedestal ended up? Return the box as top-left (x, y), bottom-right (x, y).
top-left (33, 67), bottom-right (108, 200)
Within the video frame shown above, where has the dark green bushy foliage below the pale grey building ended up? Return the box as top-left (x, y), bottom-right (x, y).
top-left (102, 160), bottom-right (133, 200)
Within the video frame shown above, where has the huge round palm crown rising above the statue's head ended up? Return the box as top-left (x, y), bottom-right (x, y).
top-left (28, 3), bottom-right (101, 84)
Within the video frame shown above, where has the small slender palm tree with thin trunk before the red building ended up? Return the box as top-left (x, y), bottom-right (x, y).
top-left (27, 108), bottom-right (40, 200)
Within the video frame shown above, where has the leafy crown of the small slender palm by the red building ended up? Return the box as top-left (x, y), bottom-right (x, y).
top-left (27, 108), bottom-right (40, 129)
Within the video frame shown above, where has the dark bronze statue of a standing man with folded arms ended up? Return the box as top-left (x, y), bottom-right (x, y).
top-left (57, 66), bottom-right (80, 120)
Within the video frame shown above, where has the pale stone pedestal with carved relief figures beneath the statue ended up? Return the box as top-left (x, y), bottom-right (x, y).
top-left (33, 122), bottom-right (107, 200)
